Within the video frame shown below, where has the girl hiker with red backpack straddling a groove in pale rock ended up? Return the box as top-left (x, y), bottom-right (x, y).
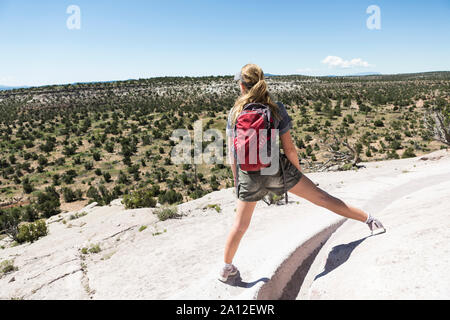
top-left (219, 64), bottom-right (385, 282)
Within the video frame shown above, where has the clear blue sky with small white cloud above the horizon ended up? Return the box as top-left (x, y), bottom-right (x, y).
top-left (0, 0), bottom-right (450, 86)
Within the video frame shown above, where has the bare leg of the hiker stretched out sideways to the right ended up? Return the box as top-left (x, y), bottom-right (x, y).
top-left (289, 175), bottom-right (369, 222)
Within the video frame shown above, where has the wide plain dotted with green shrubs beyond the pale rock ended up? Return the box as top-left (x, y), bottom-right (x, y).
top-left (0, 72), bottom-right (450, 234)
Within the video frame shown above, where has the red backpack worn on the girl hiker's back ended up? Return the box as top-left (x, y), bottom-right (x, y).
top-left (233, 103), bottom-right (275, 171)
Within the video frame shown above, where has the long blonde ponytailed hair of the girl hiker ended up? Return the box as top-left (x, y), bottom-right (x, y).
top-left (231, 64), bottom-right (281, 126)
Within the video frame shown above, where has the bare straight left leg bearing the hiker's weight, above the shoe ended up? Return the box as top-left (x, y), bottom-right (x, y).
top-left (224, 200), bottom-right (256, 264)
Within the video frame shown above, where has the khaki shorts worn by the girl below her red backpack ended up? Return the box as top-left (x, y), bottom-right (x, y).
top-left (236, 154), bottom-right (303, 202)
